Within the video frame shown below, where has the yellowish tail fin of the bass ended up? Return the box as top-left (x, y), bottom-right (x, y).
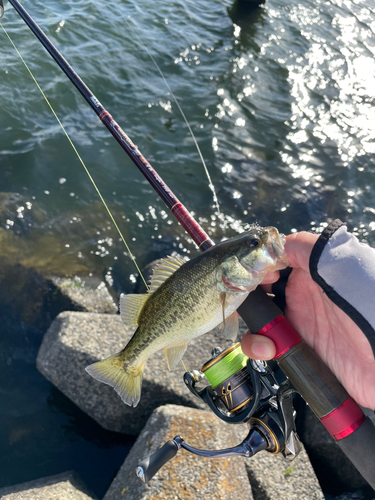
top-left (86, 353), bottom-right (145, 407)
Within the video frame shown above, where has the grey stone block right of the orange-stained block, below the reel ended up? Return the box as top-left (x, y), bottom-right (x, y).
top-left (246, 449), bottom-right (324, 500)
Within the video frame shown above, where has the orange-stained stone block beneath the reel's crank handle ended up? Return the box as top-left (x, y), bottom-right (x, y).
top-left (103, 405), bottom-right (253, 500)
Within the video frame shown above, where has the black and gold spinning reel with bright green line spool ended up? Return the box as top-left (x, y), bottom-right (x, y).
top-left (136, 343), bottom-right (301, 483)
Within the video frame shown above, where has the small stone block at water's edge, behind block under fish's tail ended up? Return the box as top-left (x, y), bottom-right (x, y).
top-left (50, 276), bottom-right (118, 314)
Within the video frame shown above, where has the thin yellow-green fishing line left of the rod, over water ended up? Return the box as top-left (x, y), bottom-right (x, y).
top-left (0, 23), bottom-right (149, 290)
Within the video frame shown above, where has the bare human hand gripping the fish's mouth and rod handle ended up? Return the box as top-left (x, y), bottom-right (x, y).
top-left (241, 232), bottom-right (375, 410)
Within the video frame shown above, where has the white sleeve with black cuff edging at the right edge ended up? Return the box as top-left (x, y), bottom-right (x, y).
top-left (310, 220), bottom-right (375, 354)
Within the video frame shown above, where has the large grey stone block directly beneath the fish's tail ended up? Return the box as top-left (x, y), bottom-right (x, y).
top-left (37, 311), bottom-right (235, 435)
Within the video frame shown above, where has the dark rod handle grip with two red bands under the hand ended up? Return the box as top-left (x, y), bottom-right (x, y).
top-left (238, 287), bottom-right (375, 489)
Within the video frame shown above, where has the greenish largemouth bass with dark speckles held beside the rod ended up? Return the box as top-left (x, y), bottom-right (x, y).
top-left (86, 226), bottom-right (288, 407)
